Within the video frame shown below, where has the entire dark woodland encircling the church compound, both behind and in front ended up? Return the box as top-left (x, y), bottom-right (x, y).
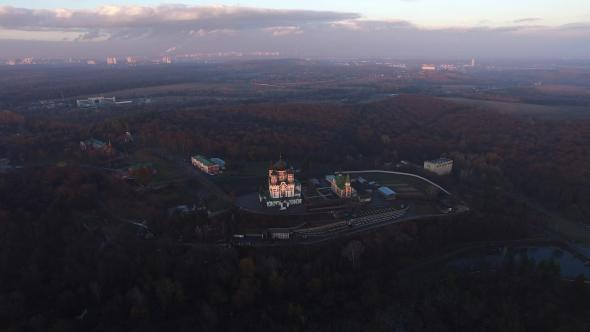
top-left (0, 63), bottom-right (590, 331)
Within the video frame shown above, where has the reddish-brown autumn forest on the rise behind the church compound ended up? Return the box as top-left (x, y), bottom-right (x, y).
top-left (70, 95), bottom-right (590, 221)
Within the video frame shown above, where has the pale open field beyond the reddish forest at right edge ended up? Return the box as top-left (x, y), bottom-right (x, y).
top-left (441, 98), bottom-right (590, 118)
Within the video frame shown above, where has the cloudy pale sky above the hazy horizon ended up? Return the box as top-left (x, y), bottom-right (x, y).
top-left (0, 0), bottom-right (590, 58)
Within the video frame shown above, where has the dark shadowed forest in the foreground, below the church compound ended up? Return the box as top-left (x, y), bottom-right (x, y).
top-left (0, 165), bottom-right (590, 331)
